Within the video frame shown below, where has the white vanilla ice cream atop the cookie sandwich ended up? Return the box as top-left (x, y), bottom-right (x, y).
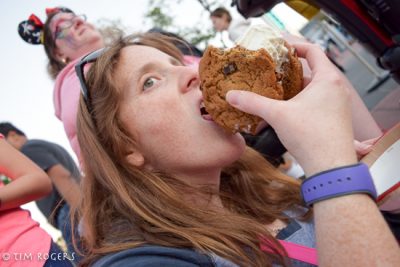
top-left (236, 24), bottom-right (288, 73)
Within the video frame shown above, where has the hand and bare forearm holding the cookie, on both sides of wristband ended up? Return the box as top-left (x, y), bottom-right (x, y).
top-left (226, 44), bottom-right (400, 266)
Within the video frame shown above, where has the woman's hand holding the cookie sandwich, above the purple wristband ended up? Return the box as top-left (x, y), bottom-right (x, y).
top-left (226, 43), bottom-right (357, 175)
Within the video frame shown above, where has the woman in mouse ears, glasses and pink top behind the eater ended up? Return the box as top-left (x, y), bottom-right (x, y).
top-left (18, 7), bottom-right (199, 159)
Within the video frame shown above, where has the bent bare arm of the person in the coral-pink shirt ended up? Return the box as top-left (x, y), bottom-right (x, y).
top-left (0, 137), bottom-right (52, 210)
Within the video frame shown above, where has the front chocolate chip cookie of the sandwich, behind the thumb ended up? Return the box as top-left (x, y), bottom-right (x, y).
top-left (199, 46), bottom-right (284, 134)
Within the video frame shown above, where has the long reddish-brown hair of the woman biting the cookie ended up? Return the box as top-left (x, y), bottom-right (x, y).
top-left (77, 33), bottom-right (301, 266)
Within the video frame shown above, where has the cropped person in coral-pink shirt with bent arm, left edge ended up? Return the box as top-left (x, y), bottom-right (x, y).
top-left (0, 134), bottom-right (72, 267)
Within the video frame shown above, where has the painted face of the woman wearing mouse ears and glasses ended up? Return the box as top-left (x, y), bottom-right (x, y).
top-left (50, 12), bottom-right (103, 61)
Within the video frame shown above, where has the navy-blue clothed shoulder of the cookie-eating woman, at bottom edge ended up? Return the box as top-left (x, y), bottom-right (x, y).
top-left (92, 246), bottom-right (214, 267)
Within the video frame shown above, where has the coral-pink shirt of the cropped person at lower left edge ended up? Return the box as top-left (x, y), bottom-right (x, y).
top-left (0, 134), bottom-right (51, 267)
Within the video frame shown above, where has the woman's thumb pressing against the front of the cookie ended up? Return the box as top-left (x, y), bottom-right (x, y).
top-left (226, 90), bottom-right (277, 121)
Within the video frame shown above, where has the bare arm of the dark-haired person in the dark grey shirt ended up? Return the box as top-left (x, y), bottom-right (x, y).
top-left (46, 164), bottom-right (81, 207)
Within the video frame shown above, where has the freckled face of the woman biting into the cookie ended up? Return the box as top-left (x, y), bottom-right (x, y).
top-left (116, 45), bottom-right (245, 174)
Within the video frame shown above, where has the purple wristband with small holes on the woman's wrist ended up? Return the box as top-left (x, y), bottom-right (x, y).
top-left (301, 163), bottom-right (377, 206)
